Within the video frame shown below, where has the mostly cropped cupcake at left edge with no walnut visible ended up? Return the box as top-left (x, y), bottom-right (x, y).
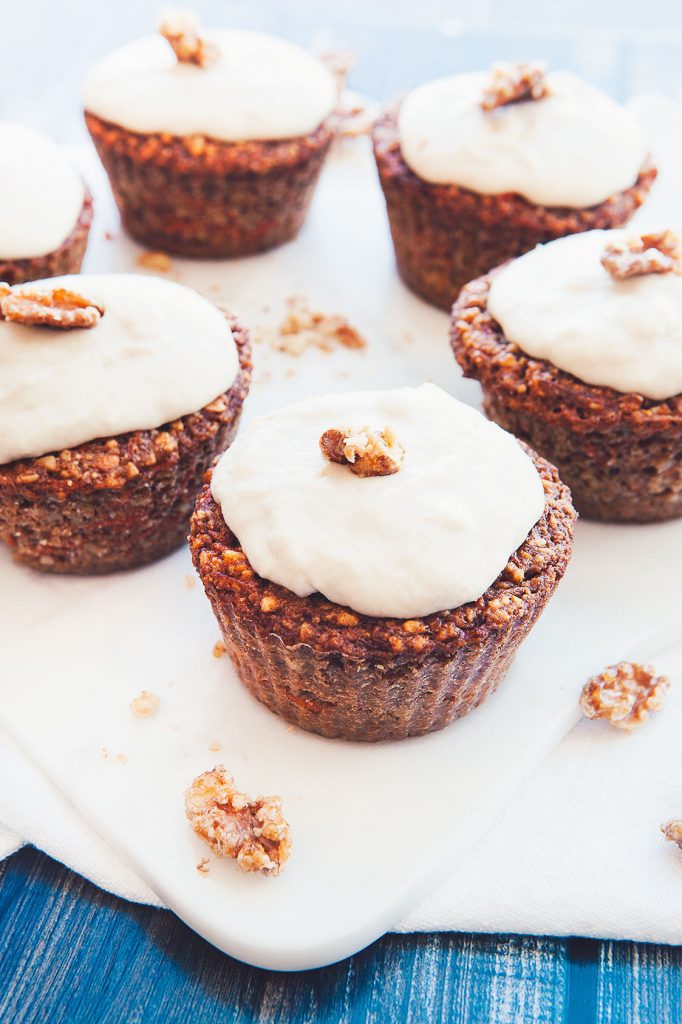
top-left (0, 121), bottom-right (92, 285)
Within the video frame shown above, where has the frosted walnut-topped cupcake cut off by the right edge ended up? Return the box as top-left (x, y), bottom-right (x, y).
top-left (452, 231), bottom-right (682, 522)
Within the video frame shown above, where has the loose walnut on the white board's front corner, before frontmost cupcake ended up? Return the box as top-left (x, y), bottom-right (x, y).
top-left (184, 765), bottom-right (292, 874)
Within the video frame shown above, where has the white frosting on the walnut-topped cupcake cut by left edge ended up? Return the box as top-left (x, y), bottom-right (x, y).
top-left (0, 273), bottom-right (239, 463)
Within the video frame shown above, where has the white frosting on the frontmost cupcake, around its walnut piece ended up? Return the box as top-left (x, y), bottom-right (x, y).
top-left (212, 384), bottom-right (545, 618)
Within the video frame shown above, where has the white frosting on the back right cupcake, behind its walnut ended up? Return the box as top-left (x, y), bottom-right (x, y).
top-left (398, 72), bottom-right (646, 207)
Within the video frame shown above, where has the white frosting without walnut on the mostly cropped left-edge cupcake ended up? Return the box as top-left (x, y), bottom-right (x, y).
top-left (0, 121), bottom-right (85, 260)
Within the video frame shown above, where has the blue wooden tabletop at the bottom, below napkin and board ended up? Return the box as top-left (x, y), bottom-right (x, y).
top-left (0, 849), bottom-right (682, 1024)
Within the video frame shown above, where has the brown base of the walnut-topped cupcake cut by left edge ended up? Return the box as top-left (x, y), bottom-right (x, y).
top-left (0, 317), bottom-right (252, 574)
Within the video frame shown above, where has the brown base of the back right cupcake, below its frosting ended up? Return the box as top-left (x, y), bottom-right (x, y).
top-left (374, 110), bottom-right (656, 311)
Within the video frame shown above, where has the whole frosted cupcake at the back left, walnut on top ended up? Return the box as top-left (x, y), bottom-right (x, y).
top-left (85, 15), bottom-right (337, 257)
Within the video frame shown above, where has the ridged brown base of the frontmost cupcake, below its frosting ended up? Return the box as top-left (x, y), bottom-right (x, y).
top-left (189, 453), bottom-right (576, 740)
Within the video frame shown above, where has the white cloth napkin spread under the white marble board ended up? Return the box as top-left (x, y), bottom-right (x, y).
top-left (0, 645), bottom-right (682, 943)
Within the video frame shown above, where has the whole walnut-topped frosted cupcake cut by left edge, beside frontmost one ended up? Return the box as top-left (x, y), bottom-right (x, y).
top-left (0, 274), bottom-right (251, 573)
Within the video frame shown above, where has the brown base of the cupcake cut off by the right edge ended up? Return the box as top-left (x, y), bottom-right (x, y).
top-left (451, 274), bottom-right (682, 522)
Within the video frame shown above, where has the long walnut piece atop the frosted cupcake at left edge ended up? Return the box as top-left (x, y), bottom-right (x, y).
top-left (0, 285), bottom-right (104, 331)
